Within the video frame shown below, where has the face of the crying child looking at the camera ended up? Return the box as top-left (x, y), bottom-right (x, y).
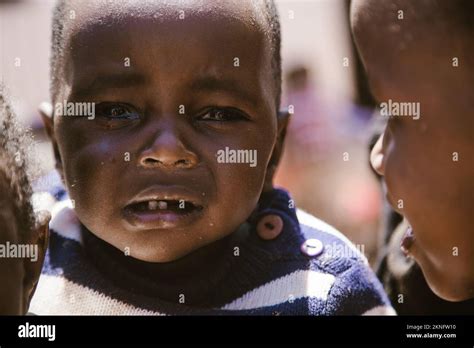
top-left (46, 1), bottom-right (282, 262)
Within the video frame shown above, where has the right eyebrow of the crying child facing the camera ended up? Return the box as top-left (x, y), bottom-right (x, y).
top-left (190, 76), bottom-right (258, 106)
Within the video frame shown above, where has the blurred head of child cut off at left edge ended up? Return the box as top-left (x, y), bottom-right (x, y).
top-left (0, 91), bottom-right (48, 315)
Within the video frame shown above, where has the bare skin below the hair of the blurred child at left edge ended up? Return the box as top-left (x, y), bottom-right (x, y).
top-left (0, 171), bottom-right (49, 315)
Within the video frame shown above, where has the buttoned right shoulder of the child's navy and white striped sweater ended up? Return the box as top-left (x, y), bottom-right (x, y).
top-left (219, 208), bottom-right (395, 315)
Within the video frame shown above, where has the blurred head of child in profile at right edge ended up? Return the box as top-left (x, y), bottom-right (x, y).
top-left (351, 0), bottom-right (474, 300)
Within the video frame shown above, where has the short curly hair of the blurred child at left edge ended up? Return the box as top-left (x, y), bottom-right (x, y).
top-left (0, 85), bottom-right (38, 240)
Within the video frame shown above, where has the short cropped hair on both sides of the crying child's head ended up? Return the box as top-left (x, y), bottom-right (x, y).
top-left (50, 0), bottom-right (282, 110)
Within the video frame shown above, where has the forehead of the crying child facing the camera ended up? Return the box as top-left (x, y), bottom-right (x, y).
top-left (59, 1), bottom-right (273, 109)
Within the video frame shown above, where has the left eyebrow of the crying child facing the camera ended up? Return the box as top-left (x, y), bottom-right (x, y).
top-left (71, 72), bottom-right (148, 98)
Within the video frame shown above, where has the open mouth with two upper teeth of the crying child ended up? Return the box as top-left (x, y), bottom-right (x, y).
top-left (123, 186), bottom-right (204, 230)
